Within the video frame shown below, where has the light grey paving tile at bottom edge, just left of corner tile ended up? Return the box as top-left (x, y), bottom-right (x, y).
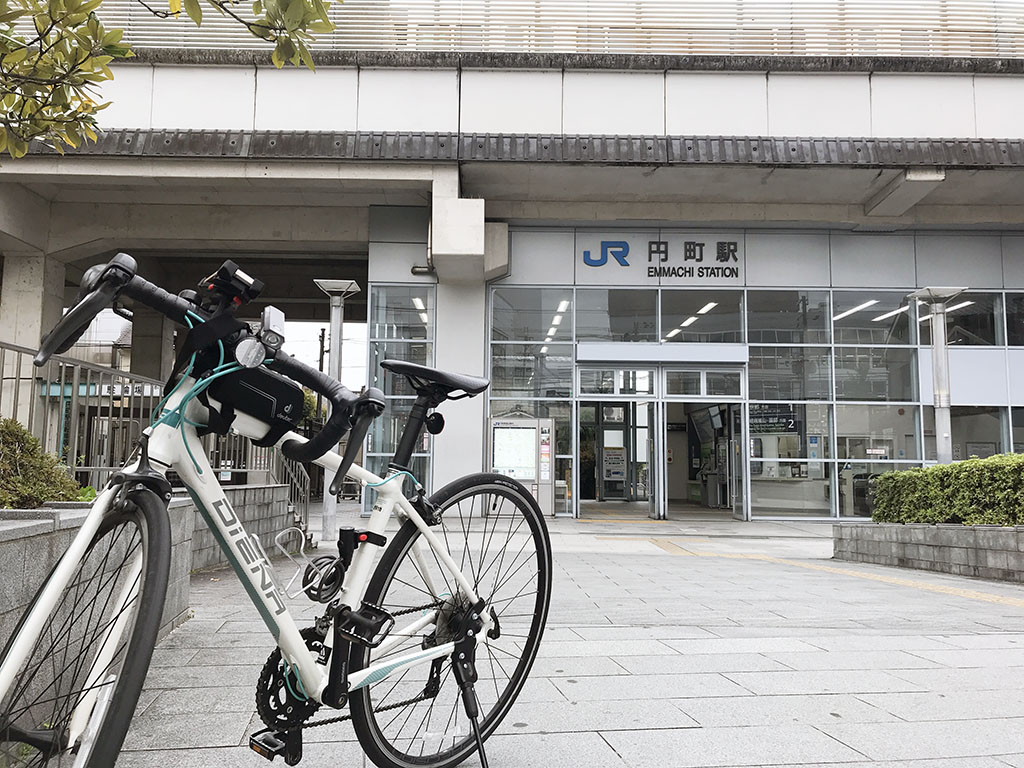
top-left (603, 725), bottom-right (863, 768)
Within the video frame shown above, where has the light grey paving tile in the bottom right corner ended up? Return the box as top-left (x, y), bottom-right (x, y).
top-left (821, 718), bottom-right (1024, 760)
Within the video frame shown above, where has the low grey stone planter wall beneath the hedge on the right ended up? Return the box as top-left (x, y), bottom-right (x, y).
top-left (833, 522), bottom-right (1024, 583)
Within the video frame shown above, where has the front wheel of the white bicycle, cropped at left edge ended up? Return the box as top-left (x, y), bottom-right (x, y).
top-left (0, 490), bottom-right (171, 768)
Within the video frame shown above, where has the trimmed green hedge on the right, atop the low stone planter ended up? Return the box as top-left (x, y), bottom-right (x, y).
top-left (871, 454), bottom-right (1024, 525)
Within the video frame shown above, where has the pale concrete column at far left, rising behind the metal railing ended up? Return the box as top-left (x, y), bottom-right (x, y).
top-left (0, 252), bottom-right (65, 349)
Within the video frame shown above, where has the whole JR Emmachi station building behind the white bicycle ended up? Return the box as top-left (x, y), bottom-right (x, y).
top-left (0, 0), bottom-right (1024, 520)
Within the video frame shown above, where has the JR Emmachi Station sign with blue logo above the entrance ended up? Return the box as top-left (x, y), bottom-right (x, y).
top-left (575, 229), bottom-right (746, 288)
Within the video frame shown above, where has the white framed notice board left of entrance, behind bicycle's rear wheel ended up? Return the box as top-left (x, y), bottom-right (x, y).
top-left (487, 418), bottom-right (556, 515)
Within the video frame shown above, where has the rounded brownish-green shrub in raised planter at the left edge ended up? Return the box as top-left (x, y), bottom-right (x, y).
top-left (0, 419), bottom-right (81, 509)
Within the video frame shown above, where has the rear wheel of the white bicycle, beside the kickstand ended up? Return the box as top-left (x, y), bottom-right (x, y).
top-left (349, 474), bottom-right (552, 768)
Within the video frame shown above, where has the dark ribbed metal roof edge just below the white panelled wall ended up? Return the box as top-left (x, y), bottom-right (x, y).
top-left (32, 129), bottom-right (1024, 168)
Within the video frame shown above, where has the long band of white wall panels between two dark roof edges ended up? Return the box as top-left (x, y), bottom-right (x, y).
top-left (100, 65), bottom-right (1024, 138)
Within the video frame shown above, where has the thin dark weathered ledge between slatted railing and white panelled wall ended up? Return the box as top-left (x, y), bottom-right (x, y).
top-left (118, 48), bottom-right (1024, 75)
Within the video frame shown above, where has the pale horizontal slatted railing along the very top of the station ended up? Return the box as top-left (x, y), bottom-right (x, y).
top-left (102, 0), bottom-right (1024, 57)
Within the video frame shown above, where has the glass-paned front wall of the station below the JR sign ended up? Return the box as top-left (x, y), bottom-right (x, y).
top-left (368, 232), bottom-right (1024, 517)
